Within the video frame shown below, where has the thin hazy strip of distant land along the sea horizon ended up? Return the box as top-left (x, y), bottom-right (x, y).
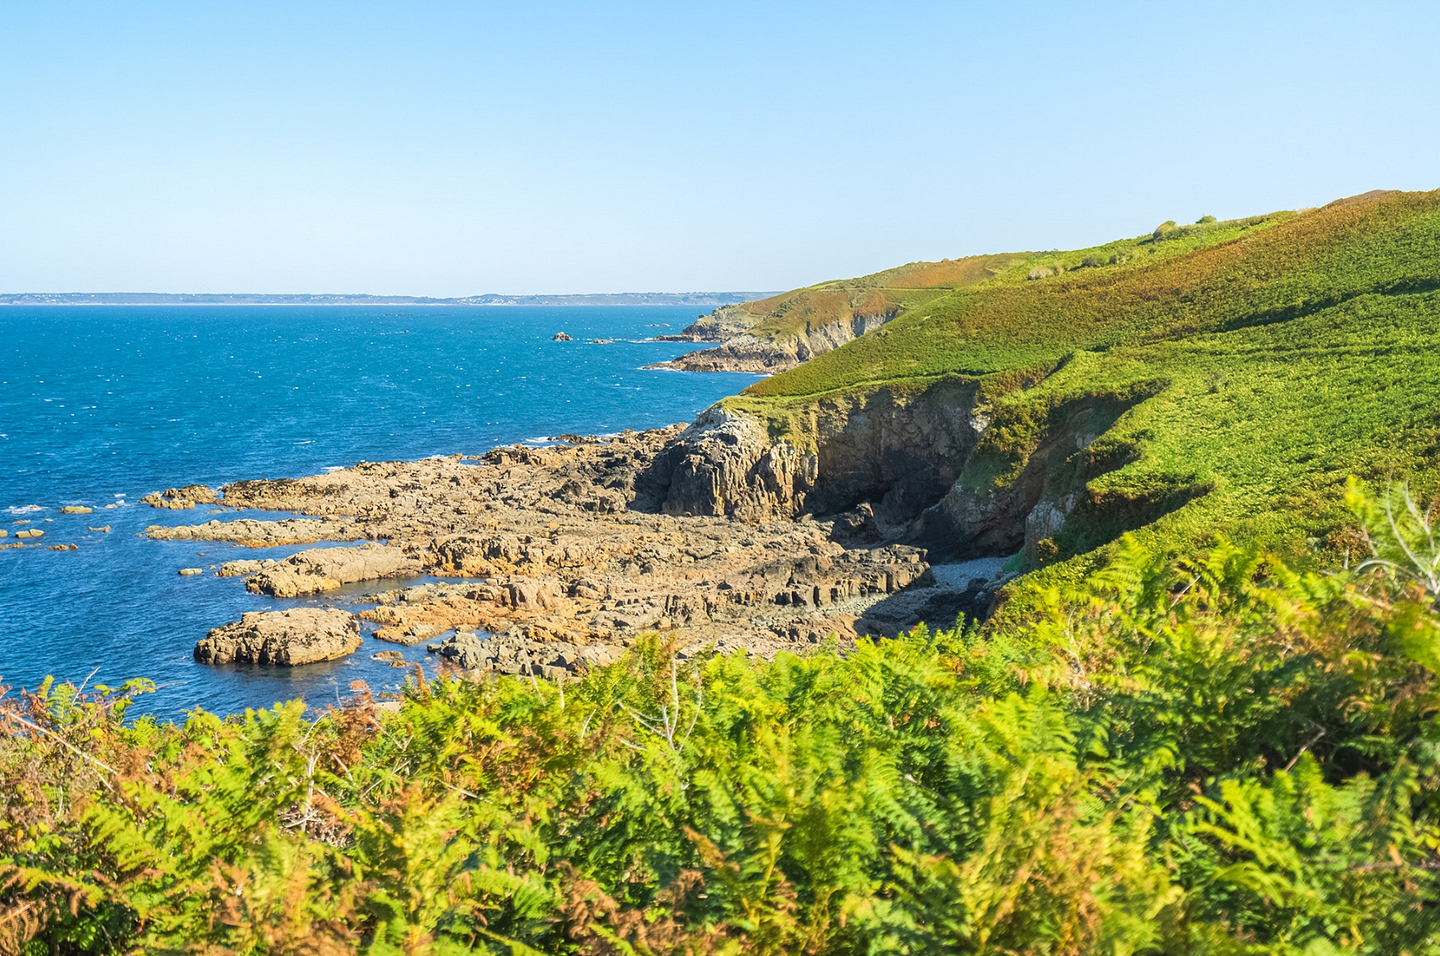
top-left (0, 292), bottom-right (773, 308)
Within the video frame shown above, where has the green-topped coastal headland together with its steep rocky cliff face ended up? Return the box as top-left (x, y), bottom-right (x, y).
top-left (657, 191), bottom-right (1440, 587)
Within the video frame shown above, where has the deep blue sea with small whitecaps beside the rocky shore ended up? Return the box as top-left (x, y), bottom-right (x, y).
top-left (0, 307), bottom-right (755, 717)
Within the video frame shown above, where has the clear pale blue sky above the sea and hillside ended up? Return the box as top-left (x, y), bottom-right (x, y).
top-left (0, 0), bottom-right (1440, 297)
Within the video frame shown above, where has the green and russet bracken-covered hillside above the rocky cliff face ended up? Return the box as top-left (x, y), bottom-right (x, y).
top-left (733, 193), bottom-right (1440, 572)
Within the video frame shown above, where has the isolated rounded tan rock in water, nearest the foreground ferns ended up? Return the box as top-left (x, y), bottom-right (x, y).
top-left (194, 608), bottom-right (360, 667)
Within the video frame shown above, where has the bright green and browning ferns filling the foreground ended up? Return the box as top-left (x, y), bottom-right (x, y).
top-left (0, 495), bottom-right (1440, 955)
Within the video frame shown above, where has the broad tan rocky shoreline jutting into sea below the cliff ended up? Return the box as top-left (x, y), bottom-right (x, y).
top-left (148, 415), bottom-right (1001, 675)
